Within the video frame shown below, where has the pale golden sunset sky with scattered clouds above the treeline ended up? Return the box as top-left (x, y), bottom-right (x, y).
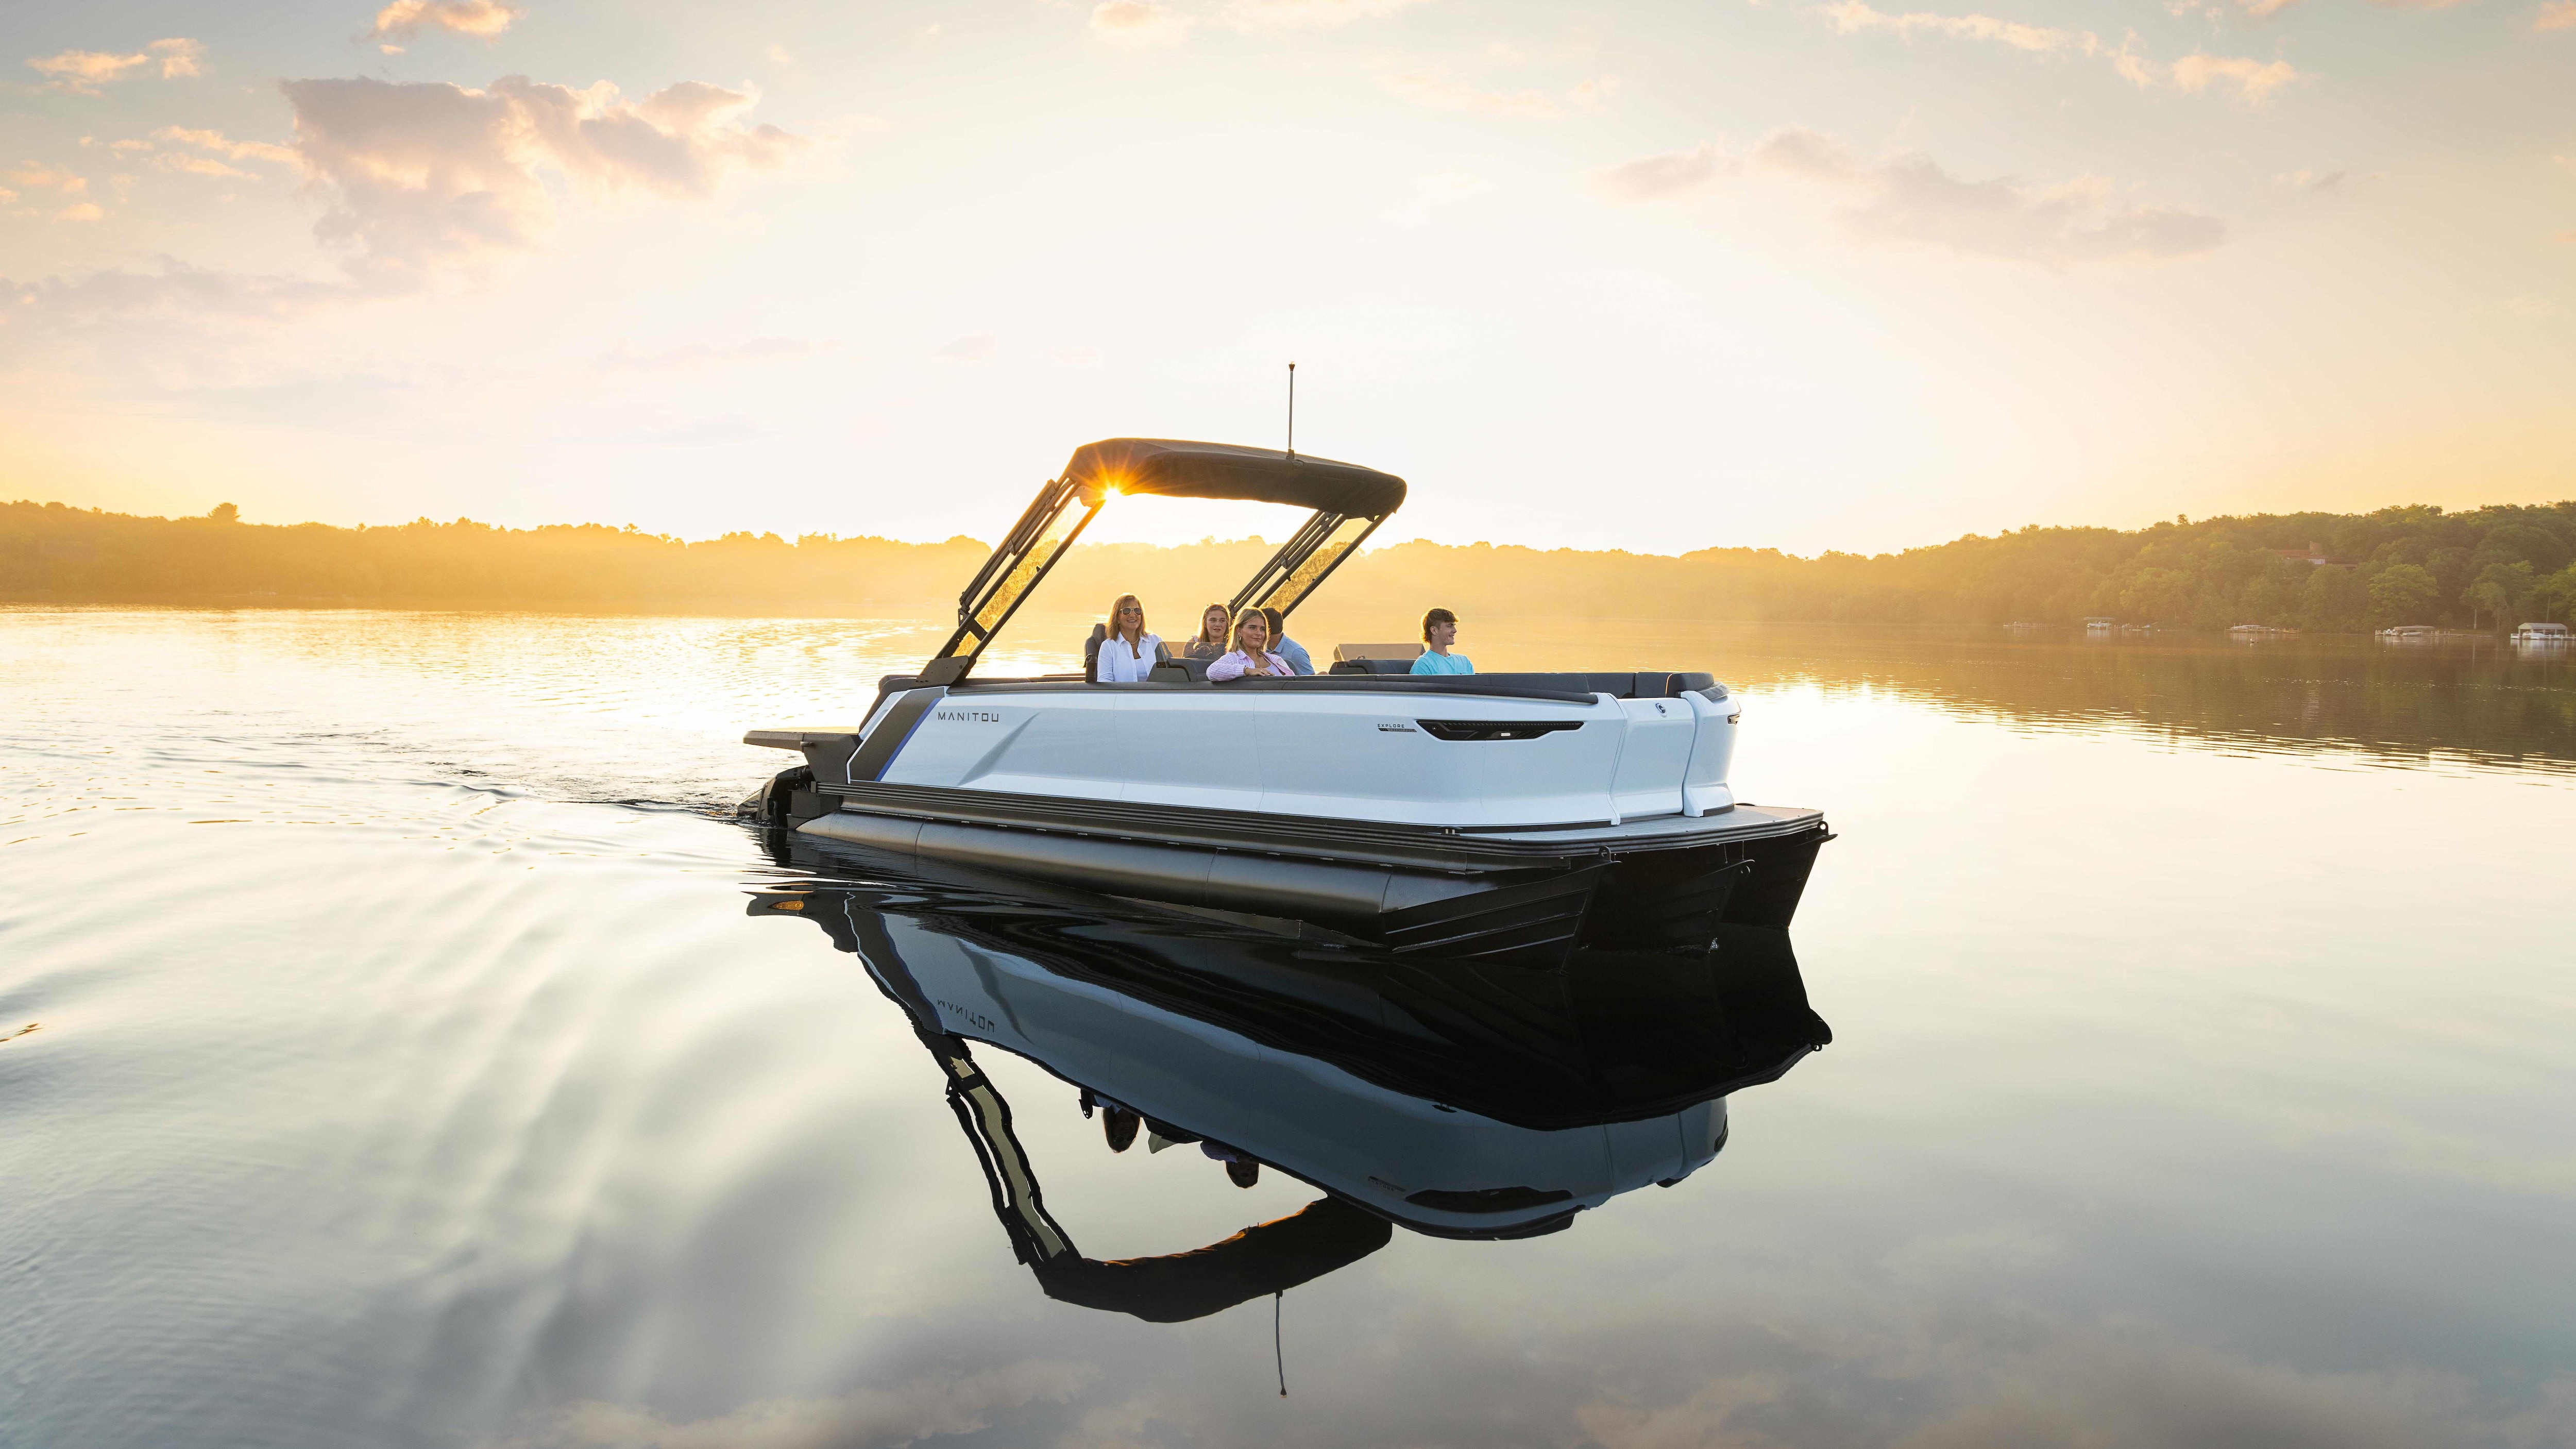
top-left (0, 0), bottom-right (2576, 552)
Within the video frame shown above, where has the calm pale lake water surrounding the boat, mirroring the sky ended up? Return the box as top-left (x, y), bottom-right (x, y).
top-left (0, 609), bottom-right (2576, 1449)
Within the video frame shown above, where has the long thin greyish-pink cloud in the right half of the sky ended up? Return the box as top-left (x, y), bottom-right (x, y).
top-left (1749, 129), bottom-right (2228, 265)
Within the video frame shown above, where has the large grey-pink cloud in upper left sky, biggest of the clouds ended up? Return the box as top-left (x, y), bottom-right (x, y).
top-left (283, 75), bottom-right (809, 276)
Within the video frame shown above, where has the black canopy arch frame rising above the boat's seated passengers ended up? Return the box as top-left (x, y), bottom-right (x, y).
top-left (920, 439), bottom-right (1404, 683)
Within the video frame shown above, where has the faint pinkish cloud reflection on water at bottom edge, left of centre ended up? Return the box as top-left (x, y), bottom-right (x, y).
top-left (507, 1359), bottom-right (1095, 1449)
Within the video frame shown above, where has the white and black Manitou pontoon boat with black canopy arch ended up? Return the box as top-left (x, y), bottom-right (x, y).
top-left (744, 439), bottom-right (1832, 964)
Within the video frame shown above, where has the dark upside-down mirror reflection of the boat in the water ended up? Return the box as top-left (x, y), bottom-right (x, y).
top-left (750, 835), bottom-right (1832, 1323)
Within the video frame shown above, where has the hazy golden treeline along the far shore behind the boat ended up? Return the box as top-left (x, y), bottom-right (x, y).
top-left (0, 490), bottom-right (2576, 634)
